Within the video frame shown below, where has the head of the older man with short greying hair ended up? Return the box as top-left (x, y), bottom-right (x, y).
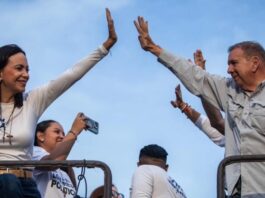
top-left (227, 41), bottom-right (265, 91)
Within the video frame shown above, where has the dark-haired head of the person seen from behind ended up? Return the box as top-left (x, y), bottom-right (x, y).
top-left (137, 144), bottom-right (168, 171)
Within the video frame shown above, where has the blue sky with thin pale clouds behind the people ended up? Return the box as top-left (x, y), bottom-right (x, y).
top-left (0, 0), bottom-right (265, 198)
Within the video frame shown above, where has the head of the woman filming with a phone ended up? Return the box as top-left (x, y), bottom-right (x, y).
top-left (34, 120), bottom-right (65, 152)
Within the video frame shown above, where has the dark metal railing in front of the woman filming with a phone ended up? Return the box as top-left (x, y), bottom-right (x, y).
top-left (0, 160), bottom-right (112, 198)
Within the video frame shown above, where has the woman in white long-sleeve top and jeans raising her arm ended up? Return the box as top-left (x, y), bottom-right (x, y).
top-left (0, 9), bottom-right (117, 198)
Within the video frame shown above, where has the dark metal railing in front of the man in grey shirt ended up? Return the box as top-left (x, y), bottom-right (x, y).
top-left (217, 155), bottom-right (265, 198)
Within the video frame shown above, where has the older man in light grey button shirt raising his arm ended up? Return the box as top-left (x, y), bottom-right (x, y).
top-left (134, 17), bottom-right (265, 198)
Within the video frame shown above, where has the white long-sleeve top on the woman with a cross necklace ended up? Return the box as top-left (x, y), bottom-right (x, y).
top-left (0, 46), bottom-right (108, 160)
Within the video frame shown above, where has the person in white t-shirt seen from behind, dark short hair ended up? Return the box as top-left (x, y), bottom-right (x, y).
top-left (130, 144), bottom-right (186, 198)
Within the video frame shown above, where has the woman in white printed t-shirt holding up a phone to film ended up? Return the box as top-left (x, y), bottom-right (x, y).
top-left (33, 113), bottom-right (88, 198)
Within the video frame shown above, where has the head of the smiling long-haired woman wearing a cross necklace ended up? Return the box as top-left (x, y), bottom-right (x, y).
top-left (0, 44), bottom-right (29, 107)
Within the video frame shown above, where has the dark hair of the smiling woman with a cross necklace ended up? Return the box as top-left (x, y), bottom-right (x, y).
top-left (0, 44), bottom-right (26, 107)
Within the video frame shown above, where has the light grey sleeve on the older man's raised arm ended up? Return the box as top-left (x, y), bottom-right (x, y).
top-left (158, 50), bottom-right (228, 111)
